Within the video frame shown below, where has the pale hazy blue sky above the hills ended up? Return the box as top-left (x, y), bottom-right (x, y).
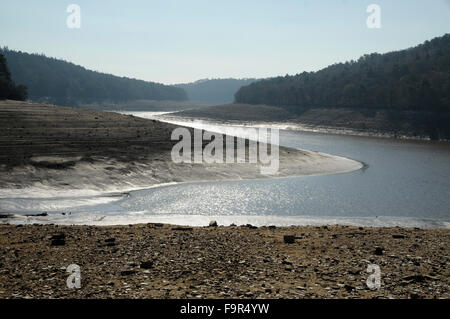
top-left (0, 0), bottom-right (450, 84)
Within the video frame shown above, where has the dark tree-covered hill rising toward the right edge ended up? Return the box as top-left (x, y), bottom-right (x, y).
top-left (235, 34), bottom-right (450, 113)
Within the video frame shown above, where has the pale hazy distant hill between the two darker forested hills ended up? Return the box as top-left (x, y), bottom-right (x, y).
top-left (175, 79), bottom-right (257, 105)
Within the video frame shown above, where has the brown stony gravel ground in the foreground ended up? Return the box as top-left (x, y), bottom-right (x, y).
top-left (0, 224), bottom-right (450, 298)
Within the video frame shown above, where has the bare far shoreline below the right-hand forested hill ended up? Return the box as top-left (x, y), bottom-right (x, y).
top-left (168, 103), bottom-right (449, 142)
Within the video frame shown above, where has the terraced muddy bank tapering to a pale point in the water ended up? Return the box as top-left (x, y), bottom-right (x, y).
top-left (0, 101), bottom-right (362, 195)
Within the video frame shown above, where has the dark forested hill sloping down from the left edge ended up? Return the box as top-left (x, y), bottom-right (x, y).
top-left (0, 48), bottom-right (187, 106)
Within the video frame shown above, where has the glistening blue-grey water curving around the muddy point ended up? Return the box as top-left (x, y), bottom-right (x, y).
top-left (0, 113), bottom-right (450, 227)
